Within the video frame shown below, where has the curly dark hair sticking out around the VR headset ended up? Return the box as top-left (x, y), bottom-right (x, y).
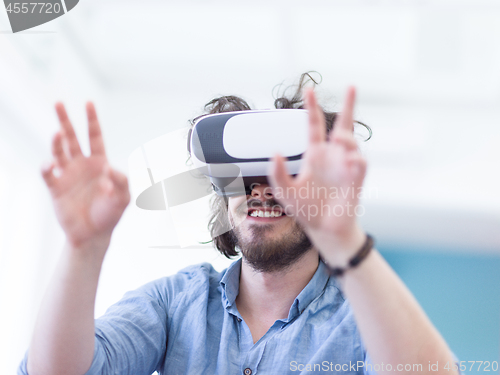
top-left (190, 72), bottom-right (372, 259)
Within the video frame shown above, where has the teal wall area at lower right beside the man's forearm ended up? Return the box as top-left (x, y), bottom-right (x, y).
top-left (380, 247), bottom-right (500, 374)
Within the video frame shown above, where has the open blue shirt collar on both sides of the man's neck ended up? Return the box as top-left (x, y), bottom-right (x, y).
top-left (220, 258), bottom-right (329, 321)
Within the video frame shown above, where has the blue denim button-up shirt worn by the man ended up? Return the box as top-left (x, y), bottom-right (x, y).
top-left (18, 259), bottom-right (418, 375)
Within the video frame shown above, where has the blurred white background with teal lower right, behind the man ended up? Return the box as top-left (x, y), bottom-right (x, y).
top-left (0, 0), bottom-right (500, 374)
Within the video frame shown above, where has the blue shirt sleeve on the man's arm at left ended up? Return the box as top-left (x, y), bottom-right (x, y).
top-left (18, 263), bottom-right (214, 375)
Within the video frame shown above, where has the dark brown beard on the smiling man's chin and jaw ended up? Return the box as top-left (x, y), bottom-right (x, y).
top-left (229, 198), bottom-right (312, 272)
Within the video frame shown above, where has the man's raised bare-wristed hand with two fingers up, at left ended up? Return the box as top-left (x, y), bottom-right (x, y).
top-left (42, 103), bottom-right (130, 253)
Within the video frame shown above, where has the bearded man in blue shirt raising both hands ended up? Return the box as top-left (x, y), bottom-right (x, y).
top-left (20, 77), bottom-right (457, 375)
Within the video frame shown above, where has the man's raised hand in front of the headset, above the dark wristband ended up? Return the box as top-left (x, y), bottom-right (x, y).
top-left (269, 87), bottom-right (366, 264)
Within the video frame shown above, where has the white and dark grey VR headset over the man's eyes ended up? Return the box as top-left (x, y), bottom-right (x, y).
top-left (187, 109), bottom-right (309, 197)
